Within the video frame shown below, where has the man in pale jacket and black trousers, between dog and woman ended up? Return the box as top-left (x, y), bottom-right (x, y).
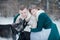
top-left (18, 4), bottom-right (37, 40)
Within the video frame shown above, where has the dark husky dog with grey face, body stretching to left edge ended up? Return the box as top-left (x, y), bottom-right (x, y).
top-left (0, 18), bottom-right (26, 37)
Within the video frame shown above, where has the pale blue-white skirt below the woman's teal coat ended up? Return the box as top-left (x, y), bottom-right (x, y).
top-left (30, 29), bottom-right (51, 40)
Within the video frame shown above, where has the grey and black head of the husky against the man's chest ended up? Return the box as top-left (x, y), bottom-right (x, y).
top-left (12, 18), bottom-right (27, 32)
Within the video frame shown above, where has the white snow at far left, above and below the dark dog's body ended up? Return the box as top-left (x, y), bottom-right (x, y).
top-left (0, 17), bottom-right (13, 40)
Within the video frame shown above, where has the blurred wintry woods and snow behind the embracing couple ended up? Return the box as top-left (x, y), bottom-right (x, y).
top-left (0, 0), bottom-right (60, 40)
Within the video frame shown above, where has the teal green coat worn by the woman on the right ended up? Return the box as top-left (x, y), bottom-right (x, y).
top-left (31, 13), bottom-right (59, 40)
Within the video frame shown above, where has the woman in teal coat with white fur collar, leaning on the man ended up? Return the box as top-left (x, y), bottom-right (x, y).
top-left (31, 5), bottom-right (59, 40)
